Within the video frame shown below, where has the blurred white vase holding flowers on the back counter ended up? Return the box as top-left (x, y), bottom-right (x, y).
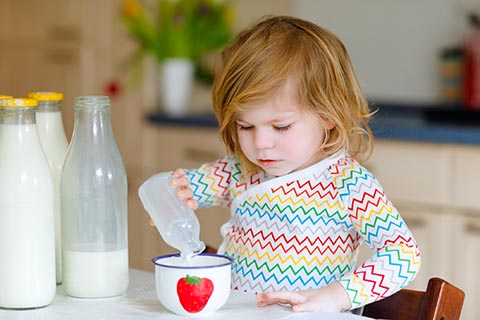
top-left (160, 58), bottom-right (194, 117)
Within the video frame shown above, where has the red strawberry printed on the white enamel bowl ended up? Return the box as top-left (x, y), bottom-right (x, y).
top-left (177, 274), bottom-right (213, 313)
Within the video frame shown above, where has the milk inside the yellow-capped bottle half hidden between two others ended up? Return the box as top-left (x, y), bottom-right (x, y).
top-left (36, 111), bottom-right (68, 284)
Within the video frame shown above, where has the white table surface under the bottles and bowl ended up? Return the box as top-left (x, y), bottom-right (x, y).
top-left (0, 269), bottom-right (376, 320)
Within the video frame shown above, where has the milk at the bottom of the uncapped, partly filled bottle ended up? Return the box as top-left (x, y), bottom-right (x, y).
top-left (62, 249), bottom-right (128, 298)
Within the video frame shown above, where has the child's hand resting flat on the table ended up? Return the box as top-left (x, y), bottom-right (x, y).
top-left (256, 281), bottom-right (350, 312)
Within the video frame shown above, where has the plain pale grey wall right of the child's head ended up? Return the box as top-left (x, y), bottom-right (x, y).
top-left (293, 0), bottom-right (480, 102)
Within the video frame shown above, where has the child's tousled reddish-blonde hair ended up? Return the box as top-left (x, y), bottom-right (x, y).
top-left (212, 16), bottom-right (373, 170)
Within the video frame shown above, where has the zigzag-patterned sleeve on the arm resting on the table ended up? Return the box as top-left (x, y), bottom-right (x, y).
top-left (332, 158), bottom-right (420, 308)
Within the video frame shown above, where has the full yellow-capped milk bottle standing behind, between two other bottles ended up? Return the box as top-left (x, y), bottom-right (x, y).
top-left (28, 92), bottom-right (68, 284)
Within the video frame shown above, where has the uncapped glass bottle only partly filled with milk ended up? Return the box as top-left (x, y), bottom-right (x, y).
top-left (60, 96), bottom-right (128, 298)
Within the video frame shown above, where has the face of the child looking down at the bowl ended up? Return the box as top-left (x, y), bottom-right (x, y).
top-left (233, 78), bottom-right (333, 176)
